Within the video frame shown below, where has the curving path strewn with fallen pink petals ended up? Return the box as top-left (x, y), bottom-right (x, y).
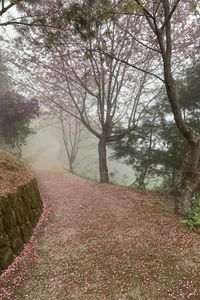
top-left (0, 171), bottom-right (200, 300)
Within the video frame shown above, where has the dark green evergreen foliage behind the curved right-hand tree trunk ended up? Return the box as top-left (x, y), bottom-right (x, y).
top-left (111, 61), bottom-right (200, 194)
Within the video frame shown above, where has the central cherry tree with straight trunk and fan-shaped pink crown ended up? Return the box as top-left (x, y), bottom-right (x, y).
top-left (9, 12), bottom-right (156, 183)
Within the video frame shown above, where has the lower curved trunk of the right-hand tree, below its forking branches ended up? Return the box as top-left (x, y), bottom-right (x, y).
top-left (164, 41), bottom-right (200, 215)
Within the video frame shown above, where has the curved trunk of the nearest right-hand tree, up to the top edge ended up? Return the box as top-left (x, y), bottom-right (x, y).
top-left (152, 0), bottom-right (200, 215)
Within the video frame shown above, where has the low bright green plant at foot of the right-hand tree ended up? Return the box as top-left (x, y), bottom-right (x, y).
top-left (182, 193), bottom-right (200, 230)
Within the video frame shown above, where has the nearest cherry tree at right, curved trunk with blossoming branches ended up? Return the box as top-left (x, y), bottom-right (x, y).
top-left (72, 0), bottom-right (200, 214)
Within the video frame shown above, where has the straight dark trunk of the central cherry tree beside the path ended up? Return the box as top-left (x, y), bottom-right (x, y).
top-left (98, 137), bottom-right (109, 183)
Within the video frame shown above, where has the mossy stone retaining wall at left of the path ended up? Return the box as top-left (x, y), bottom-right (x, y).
top-left (0, 178), bottom-right (43, 273)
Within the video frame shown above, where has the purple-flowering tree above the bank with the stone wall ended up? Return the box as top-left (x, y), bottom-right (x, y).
top-left (0, 92), bottom-right (39, 155)
